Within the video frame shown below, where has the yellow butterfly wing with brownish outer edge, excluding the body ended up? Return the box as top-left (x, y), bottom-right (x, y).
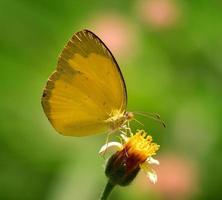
top-left (42, 30), bottom-right (127, 136)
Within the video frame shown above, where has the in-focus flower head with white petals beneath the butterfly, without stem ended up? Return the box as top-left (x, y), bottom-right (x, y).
top-left (99, 130), bottom-right (160, 186)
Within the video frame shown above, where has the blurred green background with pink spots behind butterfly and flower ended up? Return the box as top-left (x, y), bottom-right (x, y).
top-left (0, 0), bottom-right (222, 200)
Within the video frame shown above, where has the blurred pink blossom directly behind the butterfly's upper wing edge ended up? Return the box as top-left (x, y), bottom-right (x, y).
top-left (89, 12), bottom-right (137, 58)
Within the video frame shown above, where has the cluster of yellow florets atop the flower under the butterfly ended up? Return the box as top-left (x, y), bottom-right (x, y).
top-left (123, 130), bottom-right (160, 161)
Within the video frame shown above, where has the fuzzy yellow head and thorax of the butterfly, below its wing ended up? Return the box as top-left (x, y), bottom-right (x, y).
top-left (107, 111), bottom-right (134, 131)
